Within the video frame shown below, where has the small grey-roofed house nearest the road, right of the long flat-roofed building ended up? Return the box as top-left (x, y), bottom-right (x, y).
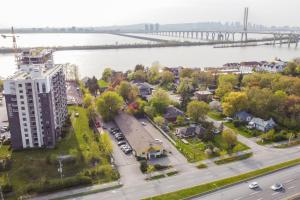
top-left (175, 125), bottom-right (206, 138)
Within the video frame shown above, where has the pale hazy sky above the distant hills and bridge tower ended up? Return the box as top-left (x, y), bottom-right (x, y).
top-left (0, 0), bottom-right (300, 28)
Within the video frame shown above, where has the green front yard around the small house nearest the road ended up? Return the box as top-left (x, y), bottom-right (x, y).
top-left (175, 135), bottom-right (249, 162)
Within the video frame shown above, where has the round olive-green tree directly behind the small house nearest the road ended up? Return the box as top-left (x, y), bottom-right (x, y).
top-left (187, 100), bottom-right (209, 122)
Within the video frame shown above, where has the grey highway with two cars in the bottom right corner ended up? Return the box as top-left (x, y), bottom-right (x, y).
top-left (194, 165), bottom-right (300, 200)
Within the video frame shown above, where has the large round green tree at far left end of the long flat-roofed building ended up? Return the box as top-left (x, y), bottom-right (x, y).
top-left (96, 91), bottom-right (124, 121)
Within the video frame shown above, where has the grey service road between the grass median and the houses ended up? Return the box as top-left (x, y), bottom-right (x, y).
top-left (73, 115), bottom-right (300, 200)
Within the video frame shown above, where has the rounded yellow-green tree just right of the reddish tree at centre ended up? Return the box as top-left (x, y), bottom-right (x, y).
top-left (149, 89), bottom-right (171, 114)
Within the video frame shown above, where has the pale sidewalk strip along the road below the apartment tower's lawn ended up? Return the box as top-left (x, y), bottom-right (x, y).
top-left (31, 181), bottom-right (123, 200)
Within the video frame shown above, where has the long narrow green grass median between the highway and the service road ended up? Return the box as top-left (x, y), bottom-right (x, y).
top-left (142, 159), bottom-right (300, 200)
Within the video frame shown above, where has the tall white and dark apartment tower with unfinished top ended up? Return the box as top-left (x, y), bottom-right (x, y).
top-left (4, 49), bottom-right (68, 149)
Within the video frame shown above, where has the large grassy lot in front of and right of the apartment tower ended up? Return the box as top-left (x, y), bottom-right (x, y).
top-left (0, 107), bottom-right (118, 196)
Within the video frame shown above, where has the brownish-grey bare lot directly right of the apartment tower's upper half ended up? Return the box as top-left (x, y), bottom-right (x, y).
top-left (66, 81), bottom-right (83, 105)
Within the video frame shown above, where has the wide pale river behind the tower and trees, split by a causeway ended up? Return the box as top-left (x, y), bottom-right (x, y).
top-left (0, 34), bottom-right (300, 78)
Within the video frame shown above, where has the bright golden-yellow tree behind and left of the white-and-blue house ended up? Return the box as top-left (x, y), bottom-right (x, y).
top-left (222, 92), bottom-right (248, 116)
